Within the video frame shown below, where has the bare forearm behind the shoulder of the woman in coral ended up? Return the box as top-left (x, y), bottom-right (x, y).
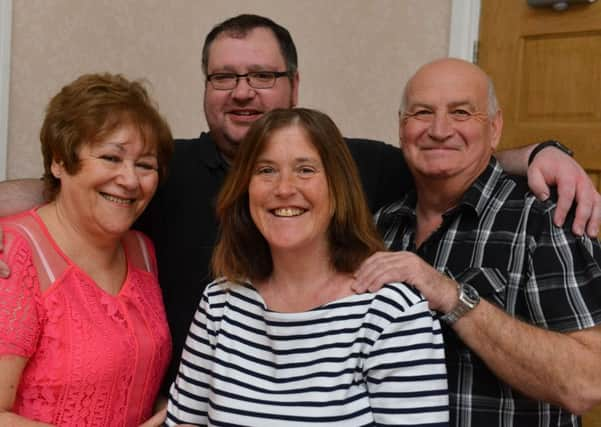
top-left (0, 179), bottom-right (44, 217)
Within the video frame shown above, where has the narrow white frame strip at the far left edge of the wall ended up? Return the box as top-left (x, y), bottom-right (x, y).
top-left (0, 0), bottom-right (12, 181)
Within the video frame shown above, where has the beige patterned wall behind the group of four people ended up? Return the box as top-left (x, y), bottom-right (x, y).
top-left (7, 0), bottom-right (451, 178)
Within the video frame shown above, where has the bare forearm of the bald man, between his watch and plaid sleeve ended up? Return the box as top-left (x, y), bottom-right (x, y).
top-left (454, 300), bottom-right (601, 413)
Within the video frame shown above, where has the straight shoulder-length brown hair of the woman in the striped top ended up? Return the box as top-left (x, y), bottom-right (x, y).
top-left (212, 108), bottom-right (384, 281)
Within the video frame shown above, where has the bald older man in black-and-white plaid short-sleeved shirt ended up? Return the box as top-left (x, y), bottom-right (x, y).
top-left (357, 59), bottom-right (601, 427)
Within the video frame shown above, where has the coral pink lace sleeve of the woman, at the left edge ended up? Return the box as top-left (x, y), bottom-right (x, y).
top-left (0, 229), bottom-right (41, 358)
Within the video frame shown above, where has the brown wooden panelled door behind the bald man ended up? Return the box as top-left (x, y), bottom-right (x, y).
top-left (478, 0), bottom-right (601, 427)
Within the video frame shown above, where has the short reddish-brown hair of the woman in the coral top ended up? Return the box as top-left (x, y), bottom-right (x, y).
top-left (40, 73), bottom-right (173, 200)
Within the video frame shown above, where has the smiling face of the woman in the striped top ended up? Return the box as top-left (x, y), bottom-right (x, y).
top-left (248, 125), bottom-right (332, 256)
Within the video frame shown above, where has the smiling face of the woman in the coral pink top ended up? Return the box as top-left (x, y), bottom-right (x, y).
top-left (51, 123), bottom-right (159, 238)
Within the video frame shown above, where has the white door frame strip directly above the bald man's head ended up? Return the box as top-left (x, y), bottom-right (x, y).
top-left (449, 0), bottom-right (480, 62)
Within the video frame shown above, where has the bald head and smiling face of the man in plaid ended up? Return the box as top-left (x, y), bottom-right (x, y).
top-left (400, 59), bottom-right (502, 183)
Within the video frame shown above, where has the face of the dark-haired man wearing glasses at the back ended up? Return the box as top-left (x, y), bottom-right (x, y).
top-left (204, 27), bottom-right (298, 161)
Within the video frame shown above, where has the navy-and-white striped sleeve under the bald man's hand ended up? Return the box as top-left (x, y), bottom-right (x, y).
top-left (365, 286), bottom-right (449, 426)
